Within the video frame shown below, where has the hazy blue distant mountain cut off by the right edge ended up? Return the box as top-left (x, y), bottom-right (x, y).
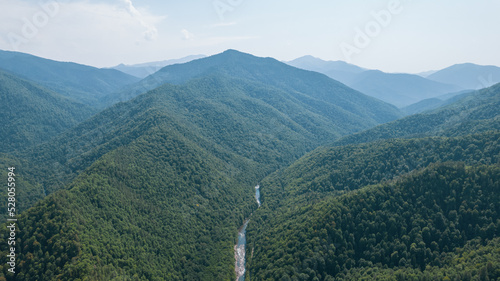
top-left (427, 63), bottom-right (500, 90)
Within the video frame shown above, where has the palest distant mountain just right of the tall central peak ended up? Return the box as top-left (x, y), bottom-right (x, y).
top-left (286, 56), bottom-right (366, 85)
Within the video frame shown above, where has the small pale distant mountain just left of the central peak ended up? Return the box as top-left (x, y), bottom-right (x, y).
top-left (113, 55), bottom-right (206, 78)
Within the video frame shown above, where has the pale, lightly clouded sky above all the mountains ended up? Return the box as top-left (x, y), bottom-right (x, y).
top-left (0, 0), bottom-right (500, 73)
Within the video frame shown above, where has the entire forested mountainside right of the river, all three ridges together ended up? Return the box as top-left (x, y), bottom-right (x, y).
top-left (247, 82), bottom-right (500, 280)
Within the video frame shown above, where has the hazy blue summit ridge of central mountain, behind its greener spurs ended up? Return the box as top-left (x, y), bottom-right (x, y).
top-left (103, 50), bottom-right (400, 128)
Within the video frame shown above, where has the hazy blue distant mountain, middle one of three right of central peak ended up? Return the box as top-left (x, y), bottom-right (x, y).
top-left (348, 70), bottom-right (461, 107)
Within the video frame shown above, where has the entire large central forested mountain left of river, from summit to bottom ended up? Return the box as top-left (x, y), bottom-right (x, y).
top-left (0, 51), bottom-right (399, 280)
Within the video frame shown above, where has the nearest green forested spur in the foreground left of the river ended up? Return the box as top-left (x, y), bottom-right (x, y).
top-left (2, 124), bottom-right (256, 280)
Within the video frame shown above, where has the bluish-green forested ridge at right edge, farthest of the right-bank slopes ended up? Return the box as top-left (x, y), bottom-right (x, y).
top-left (337, 83), bottom-right (500, 145)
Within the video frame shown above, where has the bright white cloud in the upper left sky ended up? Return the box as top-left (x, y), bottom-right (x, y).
top-left (0, 0), bottom-right (167, 66)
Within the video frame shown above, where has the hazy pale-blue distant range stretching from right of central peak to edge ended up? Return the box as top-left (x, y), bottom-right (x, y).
top-left (287, 56), bottom-right (500, 107)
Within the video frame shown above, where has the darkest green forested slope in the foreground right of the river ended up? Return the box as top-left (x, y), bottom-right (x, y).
top-left (248, 164), bottom-right (500, 280)
